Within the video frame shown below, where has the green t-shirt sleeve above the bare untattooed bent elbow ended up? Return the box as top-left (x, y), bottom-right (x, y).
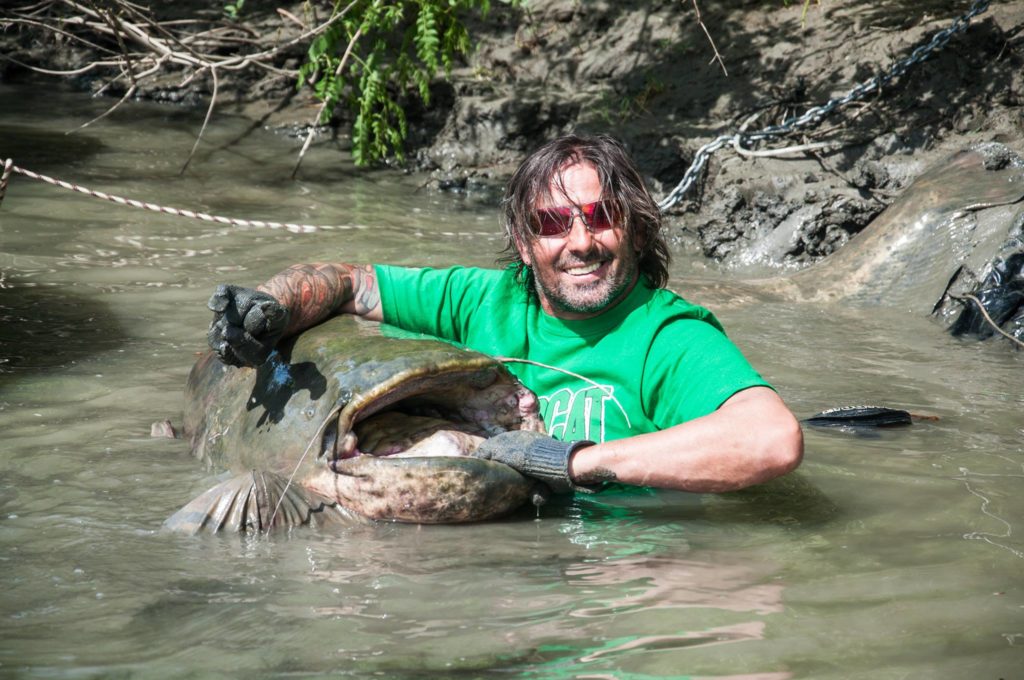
top-left (642, 317), bottom-right (771, 429)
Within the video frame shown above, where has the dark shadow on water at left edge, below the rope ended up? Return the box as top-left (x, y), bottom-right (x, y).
top-left (0, 281), bottom-right (127, 378)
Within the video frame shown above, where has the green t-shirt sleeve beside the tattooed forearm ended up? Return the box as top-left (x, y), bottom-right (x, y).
top-left (375, 264), bottom-right (486, 342)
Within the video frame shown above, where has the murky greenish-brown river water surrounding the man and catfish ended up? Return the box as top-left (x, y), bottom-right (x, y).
top-left (0, 86), bottom-right (1024, 679)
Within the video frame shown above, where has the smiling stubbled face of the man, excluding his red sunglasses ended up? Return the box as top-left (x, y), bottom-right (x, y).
top-left (517, 163), bottom-right (638, 318)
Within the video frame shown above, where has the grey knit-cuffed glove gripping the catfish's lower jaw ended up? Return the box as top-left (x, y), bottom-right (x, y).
top-left (473, 430), bottom-right (594, 494)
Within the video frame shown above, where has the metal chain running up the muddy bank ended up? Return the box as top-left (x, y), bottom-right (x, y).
top-left (657, 0), bottom-right (990, 212)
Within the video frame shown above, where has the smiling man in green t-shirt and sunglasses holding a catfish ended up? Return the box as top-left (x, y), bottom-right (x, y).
top-left (210, 135), bottom-right (803, 492)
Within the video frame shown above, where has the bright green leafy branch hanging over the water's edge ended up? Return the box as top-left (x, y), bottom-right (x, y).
top-left (298, 0), bottom-right (518, 165)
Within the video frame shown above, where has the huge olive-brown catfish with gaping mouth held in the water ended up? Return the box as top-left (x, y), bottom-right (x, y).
top-left (177, 314), bottom-right (544, 533)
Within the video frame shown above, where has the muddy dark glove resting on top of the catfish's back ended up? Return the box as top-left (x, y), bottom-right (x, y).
top-left (206, 284), bottom-right (289, 366)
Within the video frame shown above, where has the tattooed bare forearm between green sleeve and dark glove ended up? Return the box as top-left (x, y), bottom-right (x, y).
top-left (256, 262), bottom-right (383, 337)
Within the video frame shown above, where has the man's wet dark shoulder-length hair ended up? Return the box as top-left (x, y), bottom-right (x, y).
top-left (499, 134), bottom-right (672, 291)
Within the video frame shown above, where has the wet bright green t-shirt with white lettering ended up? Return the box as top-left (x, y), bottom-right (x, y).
top-left (377, 265), bottom-right (767, 442)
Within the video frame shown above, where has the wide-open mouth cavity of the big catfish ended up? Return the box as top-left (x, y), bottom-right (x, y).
top-left (321, 362), bottom-right (544, 460)
